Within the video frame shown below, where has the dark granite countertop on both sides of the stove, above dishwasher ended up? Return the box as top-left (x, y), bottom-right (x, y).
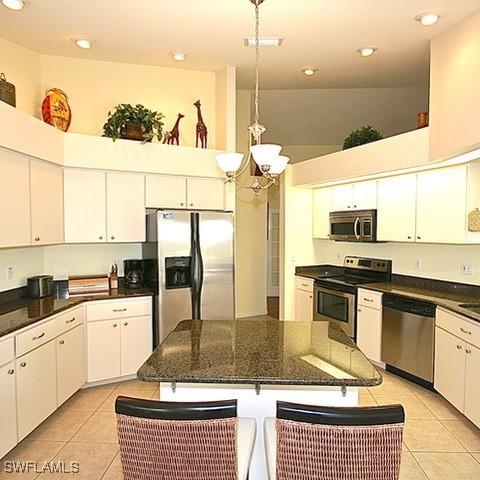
top-left (295, 265), bottom-right (480, 322)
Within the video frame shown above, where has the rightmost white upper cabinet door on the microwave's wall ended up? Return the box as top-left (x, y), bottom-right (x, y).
top-left (417, 165), bottom-right (467, 243)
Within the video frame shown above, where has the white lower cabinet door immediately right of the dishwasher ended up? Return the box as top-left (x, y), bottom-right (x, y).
top-left (434, 327), bottom-right (466, 412)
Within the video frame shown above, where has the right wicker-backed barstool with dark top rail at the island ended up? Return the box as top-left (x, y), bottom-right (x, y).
top-left (264, 402), bottom-right (405, 480)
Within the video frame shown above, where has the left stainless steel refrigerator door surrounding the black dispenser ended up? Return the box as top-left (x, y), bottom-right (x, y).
top-left (155, 210), bottom-right (192, 345)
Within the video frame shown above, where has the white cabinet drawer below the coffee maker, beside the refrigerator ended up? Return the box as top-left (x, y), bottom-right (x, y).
top-left (87, 297), bottom-right (152, 322)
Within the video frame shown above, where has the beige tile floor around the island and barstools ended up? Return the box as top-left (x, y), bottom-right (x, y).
top-left (0, 373), bottom-right (480, 480)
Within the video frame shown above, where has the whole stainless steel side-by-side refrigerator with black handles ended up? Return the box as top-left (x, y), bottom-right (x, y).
top-left (143, 210), bottom-right (235, 346)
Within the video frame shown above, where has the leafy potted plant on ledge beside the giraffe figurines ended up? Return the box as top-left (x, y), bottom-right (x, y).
top-left (103, 103), bottom-right (164, 143)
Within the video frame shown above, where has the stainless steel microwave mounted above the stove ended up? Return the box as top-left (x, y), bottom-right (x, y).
top-left (330, 210), bottom-right (377, 242)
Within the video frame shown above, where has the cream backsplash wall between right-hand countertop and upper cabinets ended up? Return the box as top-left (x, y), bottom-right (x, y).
top-left (314, 240), bottom-right (480, 284)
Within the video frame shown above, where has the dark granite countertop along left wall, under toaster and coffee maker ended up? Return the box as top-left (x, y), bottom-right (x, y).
top-left (0, 288), bottom-right (152, 337)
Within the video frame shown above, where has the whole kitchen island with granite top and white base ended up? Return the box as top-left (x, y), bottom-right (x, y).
top-left (138, 318), bottom-right (382, 480)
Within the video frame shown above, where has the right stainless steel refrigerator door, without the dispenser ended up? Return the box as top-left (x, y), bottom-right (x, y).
top-left (199, 212), bottom-right (235, 320)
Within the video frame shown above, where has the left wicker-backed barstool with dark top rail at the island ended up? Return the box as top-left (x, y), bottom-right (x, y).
top-left (115, 396), bottom-right (256, 480)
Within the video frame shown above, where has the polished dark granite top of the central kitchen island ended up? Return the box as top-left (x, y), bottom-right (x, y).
top-left (137, 318), bottom-right (382, 386)
